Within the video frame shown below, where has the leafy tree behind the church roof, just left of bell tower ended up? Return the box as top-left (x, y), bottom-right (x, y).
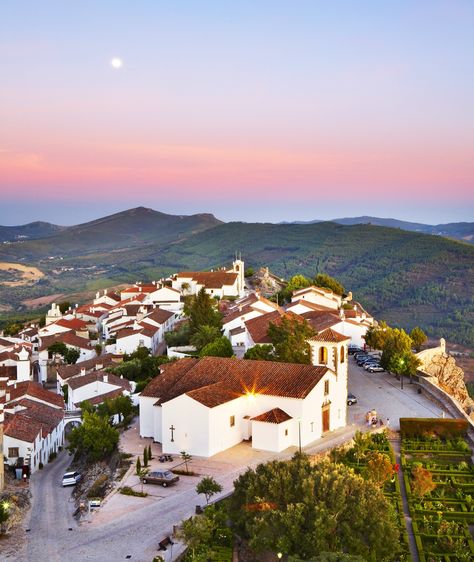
top-left (268, 316), bottom-right (314, 364)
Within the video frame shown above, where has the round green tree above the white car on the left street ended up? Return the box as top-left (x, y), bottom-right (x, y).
top-left (68, 412), bottom-right (119, 461)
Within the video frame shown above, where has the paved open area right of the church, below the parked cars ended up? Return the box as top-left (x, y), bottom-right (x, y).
top-left (348, 357), bottom-right (446, 429)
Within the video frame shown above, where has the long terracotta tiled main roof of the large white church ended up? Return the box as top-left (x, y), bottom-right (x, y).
top-left (142, 357), bottom-right (330, 405)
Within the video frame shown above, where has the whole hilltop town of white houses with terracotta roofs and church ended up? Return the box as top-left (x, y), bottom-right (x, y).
top-left (0, 258), bottom-right (474, 559)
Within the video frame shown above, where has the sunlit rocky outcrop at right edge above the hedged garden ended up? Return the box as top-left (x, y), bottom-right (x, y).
top-left (417, 339), bottom-right (474, 419)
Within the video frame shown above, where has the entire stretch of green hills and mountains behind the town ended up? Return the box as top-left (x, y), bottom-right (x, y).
top-left (0, 207), bottom-right (474, 348)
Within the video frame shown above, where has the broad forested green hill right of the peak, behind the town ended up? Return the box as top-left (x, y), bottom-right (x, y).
top-left (159, 223), bottom-right (474, 346)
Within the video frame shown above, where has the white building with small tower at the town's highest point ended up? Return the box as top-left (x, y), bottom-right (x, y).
top-left (172, 260), bottom-right (245, 299)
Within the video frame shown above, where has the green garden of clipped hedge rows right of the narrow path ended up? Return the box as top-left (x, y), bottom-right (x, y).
top-left (400, 420), bottom-right (474, 562)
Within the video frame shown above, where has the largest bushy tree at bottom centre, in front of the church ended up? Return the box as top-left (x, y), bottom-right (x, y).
top-left (229, 455), bottom-right (399, 562)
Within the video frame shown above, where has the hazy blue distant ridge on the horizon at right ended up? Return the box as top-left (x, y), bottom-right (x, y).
top-left (281, 216), bottom-right (474, 244)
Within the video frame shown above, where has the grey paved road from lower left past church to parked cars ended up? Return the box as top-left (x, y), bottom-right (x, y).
top-left (18, 359), bottom-right (452, 562)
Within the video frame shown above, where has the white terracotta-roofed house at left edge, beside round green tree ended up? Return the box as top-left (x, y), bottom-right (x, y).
top-left (4, 382), bottom-right (64, 473)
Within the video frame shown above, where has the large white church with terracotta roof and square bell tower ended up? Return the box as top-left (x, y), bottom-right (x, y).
top-left (140, 329), bottom-right (350, 457)
